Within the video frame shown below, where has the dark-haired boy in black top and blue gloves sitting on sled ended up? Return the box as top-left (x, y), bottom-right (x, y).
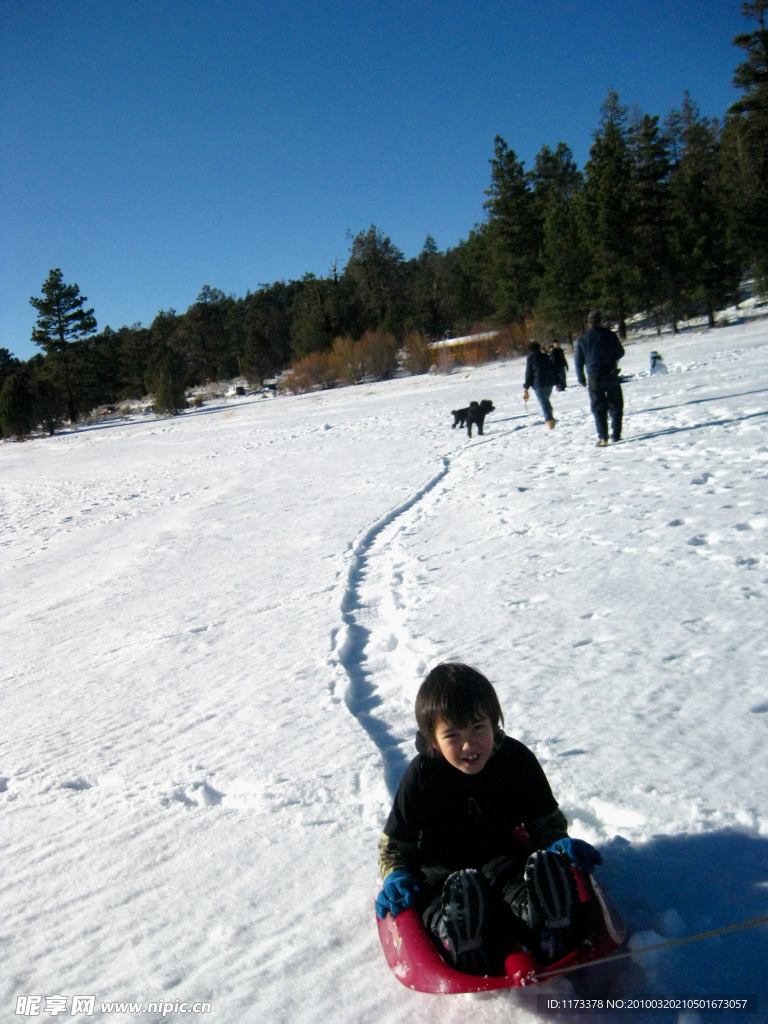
top-left (376, 663), bottom-right (602, 974)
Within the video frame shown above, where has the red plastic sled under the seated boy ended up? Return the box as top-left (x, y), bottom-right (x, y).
top-left (377, 868), bottom-right (625, 993)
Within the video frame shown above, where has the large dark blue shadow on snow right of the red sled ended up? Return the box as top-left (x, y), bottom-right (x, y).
top-left (571, 829), bottom-right (768, 1024)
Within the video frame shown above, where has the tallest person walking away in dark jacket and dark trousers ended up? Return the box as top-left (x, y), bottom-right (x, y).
top-left (574, 309), bottom-right (624, 447)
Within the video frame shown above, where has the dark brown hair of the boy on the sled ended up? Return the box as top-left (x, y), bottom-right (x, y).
top-left (415, 662), bottom-right (504, 745)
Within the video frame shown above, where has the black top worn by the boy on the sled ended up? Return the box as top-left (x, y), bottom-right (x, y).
top-left (381, 735), bottom-right (567, 877)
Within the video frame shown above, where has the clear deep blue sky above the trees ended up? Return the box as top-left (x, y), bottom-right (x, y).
top-left (0, 0), bottom-right (752, 358)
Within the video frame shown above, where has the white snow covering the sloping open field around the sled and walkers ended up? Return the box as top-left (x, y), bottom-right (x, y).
top-left (0, 318), bottom-right (768, 1024)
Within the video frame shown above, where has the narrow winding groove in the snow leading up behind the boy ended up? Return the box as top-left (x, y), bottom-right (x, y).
top-left (330, 456), bottom-right (451, 794)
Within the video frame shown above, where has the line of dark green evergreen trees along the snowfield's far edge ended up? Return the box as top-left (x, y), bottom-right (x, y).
top-left (0, 0), bottom-right (768, 437)
